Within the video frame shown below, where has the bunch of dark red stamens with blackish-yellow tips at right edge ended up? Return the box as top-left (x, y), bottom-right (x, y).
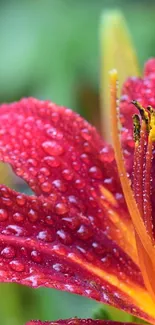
top-left (132, 100), bottom-right (155, 240)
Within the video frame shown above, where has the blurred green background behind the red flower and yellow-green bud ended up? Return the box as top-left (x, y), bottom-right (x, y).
top-left (0, 0), bottom-right (155, 325)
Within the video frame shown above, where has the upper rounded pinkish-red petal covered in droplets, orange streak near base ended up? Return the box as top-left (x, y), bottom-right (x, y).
top-left (0, 98), bottom-right (134, 261)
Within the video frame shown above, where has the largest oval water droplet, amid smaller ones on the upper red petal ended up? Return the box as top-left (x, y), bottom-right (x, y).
top-left (42, 141), bottom-right (64, 156)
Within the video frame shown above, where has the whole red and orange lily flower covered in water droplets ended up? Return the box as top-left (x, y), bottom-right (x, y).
top-left (0, 60), bottom-right (155, 325)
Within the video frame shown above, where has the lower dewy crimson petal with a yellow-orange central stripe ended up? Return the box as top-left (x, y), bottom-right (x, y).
top-left (0, 186), bottom-right (151, 318)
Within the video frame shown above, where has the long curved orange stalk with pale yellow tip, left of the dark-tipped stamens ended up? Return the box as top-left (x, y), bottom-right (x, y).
top-left (110, 70), bottom-right (155, 261)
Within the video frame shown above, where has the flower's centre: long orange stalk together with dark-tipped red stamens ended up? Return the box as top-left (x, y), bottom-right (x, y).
top-left (110, 70), bottom-right (155, 301)
